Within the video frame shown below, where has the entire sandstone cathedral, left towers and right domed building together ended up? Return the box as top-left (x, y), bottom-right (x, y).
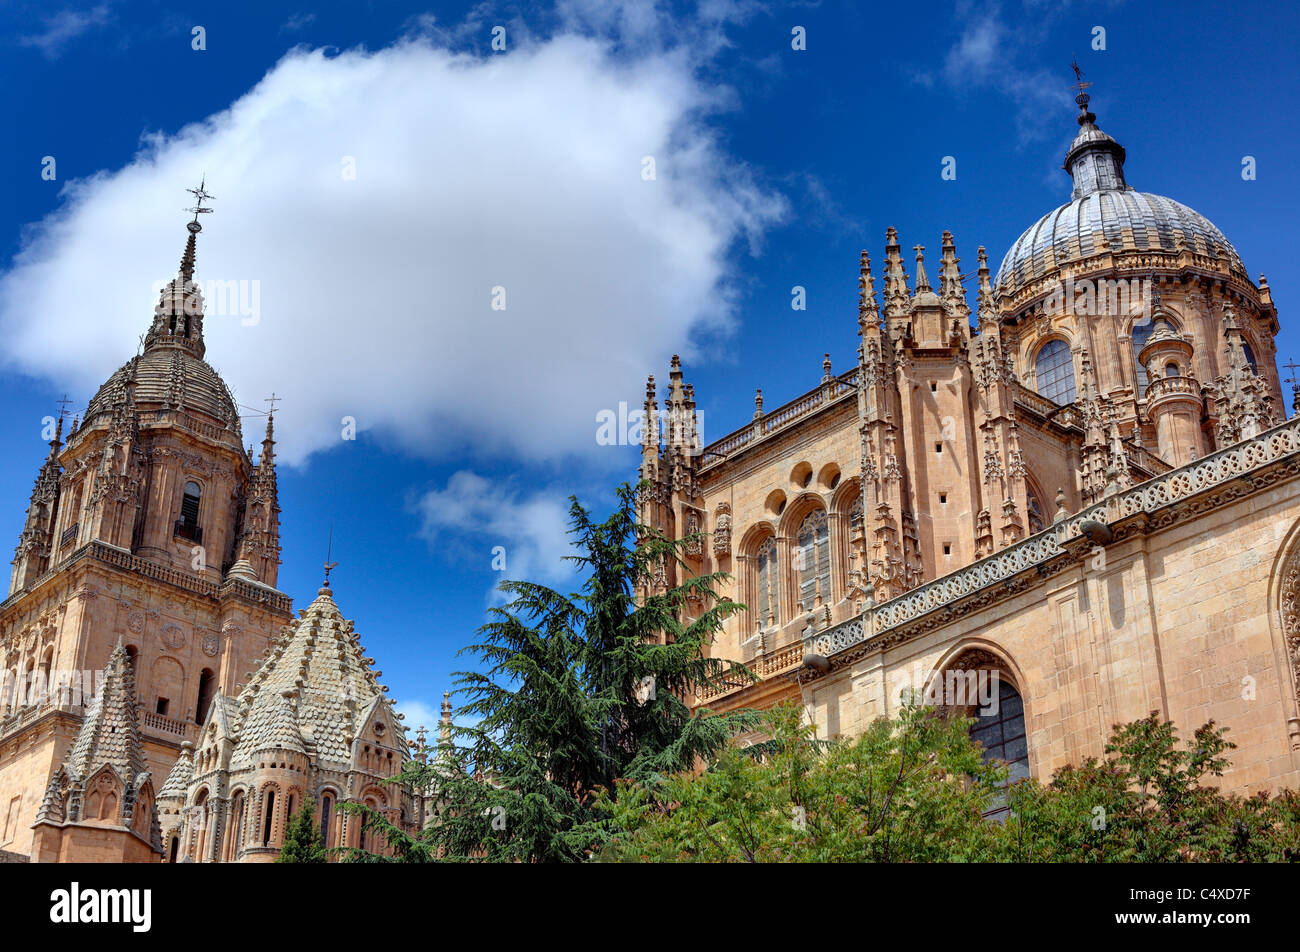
top-left (0, 86), bottom-right (1300, 862)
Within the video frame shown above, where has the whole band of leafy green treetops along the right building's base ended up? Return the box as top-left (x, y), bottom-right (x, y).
top-left (601, 705), bottom-right (1300, 862)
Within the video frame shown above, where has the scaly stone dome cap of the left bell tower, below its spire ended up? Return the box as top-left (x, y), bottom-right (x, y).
top-left (86, 346), bottom-right (239, 428)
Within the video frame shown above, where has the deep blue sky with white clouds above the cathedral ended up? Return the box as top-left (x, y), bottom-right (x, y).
top-left (0, 0), bottom-right (1300, 723)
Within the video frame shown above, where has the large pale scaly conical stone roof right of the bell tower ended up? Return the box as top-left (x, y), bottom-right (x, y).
top-left (230, 588), bottom-right (404, 770)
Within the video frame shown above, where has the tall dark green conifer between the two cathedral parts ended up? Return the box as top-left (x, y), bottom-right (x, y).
top-left (343, 484), bottom-right (755, 862)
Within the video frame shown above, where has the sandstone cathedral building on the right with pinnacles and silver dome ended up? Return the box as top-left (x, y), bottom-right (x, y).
top-left (640, 90), bottom-right (1300, 792)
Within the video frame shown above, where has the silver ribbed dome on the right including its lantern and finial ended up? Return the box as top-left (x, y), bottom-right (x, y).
top-left (993, 94), bottom-right (1245, 295)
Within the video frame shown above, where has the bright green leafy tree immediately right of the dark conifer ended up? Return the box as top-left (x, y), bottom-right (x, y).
top-left (602, 705), bottom-right (1006, 862)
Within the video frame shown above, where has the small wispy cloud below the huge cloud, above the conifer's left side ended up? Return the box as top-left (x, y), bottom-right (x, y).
top-left (415, 469), bottom-right (577, 601)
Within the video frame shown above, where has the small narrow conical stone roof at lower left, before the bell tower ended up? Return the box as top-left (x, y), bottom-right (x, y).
top-left (68, 639), bottom-right (144, 786)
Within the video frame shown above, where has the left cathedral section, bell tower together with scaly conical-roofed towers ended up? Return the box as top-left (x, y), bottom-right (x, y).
top-left (0, 200), bottom-right (426, 862)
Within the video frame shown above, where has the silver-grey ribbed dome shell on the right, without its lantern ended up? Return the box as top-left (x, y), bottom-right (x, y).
top-left (995, 187), bottom-right (1245, 294)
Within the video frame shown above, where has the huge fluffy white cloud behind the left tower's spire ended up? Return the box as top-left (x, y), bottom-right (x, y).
top-left (0, 25), bottom-right (784, 463)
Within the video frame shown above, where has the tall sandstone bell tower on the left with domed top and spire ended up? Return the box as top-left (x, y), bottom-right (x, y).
top-left (0, 183), bottom-right (293, 853)
